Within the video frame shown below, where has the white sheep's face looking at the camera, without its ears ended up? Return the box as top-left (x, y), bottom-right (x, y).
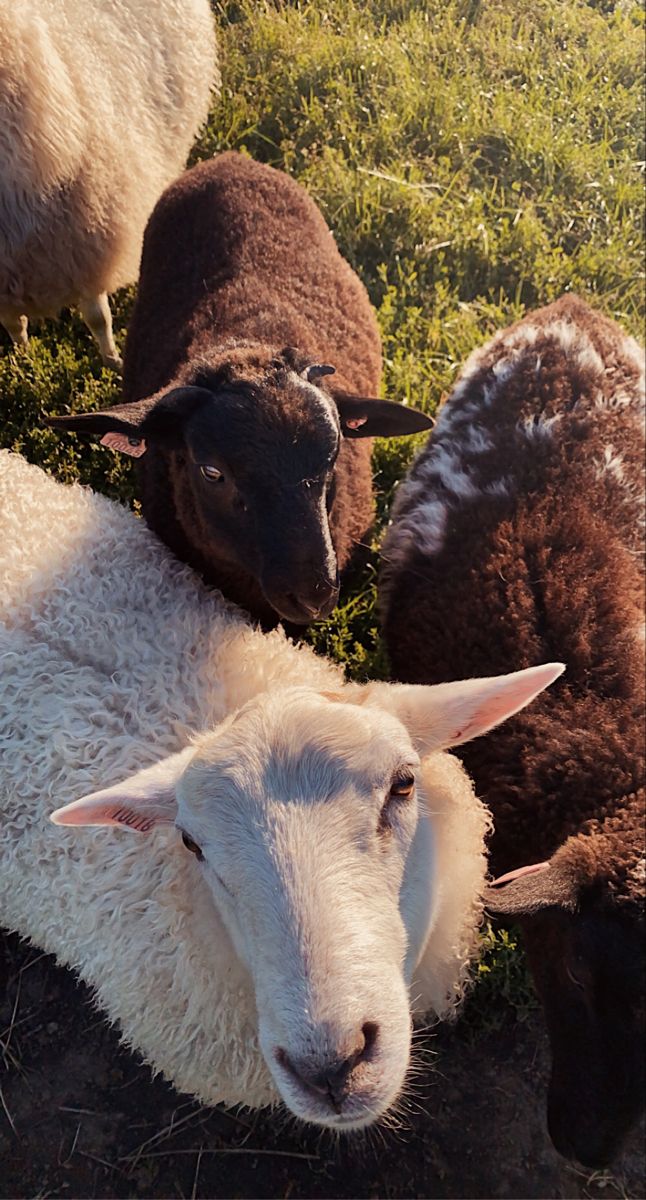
top-left (182, 689), bottom-right (419, 1127)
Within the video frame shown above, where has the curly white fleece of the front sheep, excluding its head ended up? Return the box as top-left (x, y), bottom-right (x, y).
top-left (0, 451), bottom-right (488, 1106)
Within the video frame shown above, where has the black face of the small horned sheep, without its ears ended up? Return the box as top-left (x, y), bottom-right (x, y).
top-left (172, 370), bottom-right (341, 624)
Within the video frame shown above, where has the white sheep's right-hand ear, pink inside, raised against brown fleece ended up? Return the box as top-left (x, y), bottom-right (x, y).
top-left (364, 662), bottom-right (566, 754)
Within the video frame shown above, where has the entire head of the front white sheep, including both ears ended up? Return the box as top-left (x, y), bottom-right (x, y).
top-left (52, 666), bottom-right (562, 1129)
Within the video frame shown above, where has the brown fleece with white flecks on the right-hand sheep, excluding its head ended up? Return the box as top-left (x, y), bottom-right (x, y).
top-left (381, 296), bottom-right (645, 908)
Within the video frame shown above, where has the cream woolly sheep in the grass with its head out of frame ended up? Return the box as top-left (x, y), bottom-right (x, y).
top-left (0, 0), bottom-right (217, 367)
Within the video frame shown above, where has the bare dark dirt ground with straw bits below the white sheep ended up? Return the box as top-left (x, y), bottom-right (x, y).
top-left (0, 937), bottom-right (644, 1200)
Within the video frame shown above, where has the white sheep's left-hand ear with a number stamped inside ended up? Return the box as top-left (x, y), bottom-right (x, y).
top-left (49, 746), bottom-right (195, 833)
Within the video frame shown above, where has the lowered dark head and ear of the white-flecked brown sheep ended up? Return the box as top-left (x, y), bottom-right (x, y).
top-left (486, 859), bottom-right (646, 1168)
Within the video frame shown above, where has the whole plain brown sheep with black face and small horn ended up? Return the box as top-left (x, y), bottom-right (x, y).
top-left (52, 154), bottom-right (431, 625)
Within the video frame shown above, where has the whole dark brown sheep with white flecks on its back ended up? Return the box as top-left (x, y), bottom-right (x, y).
top-left (381, 296), bottom-right (646, 1165)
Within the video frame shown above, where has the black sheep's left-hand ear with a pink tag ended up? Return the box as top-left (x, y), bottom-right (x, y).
top-left (44, 388), bottom-right (213, 457)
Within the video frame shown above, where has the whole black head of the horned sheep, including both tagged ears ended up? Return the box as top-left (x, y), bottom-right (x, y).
top-left (50, 348), bottom-right (432, 624)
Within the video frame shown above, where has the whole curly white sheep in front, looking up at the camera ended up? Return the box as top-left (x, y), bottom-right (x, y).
top-left (0, 451), bottom-right (560, 1128)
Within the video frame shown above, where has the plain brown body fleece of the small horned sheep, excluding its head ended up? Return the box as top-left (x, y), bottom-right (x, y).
top-left (118, 154), bottom-right (382, 622)
